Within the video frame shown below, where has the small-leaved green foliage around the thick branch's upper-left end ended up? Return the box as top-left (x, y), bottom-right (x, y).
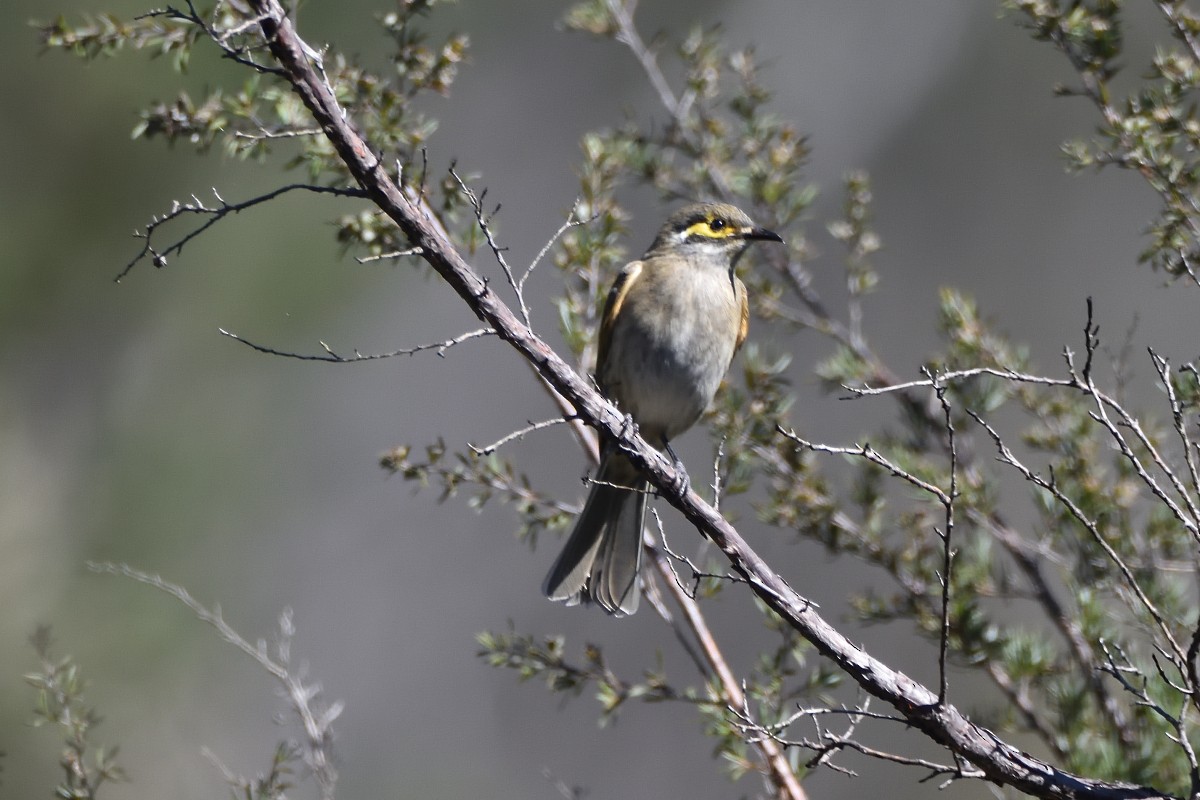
top-left (37, 0), bottom-right (479, 266)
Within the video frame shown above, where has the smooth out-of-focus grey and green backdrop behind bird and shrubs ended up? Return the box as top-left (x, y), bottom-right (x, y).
top-left (0, 0), bottom-right (1196, 800)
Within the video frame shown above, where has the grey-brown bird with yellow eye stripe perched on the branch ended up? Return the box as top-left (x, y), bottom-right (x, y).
top-left (541, 203), bottom-right (784, 616)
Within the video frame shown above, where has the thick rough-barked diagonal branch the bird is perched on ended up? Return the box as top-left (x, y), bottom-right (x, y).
top-left (243, 0), bottom-right (1170, 800)
